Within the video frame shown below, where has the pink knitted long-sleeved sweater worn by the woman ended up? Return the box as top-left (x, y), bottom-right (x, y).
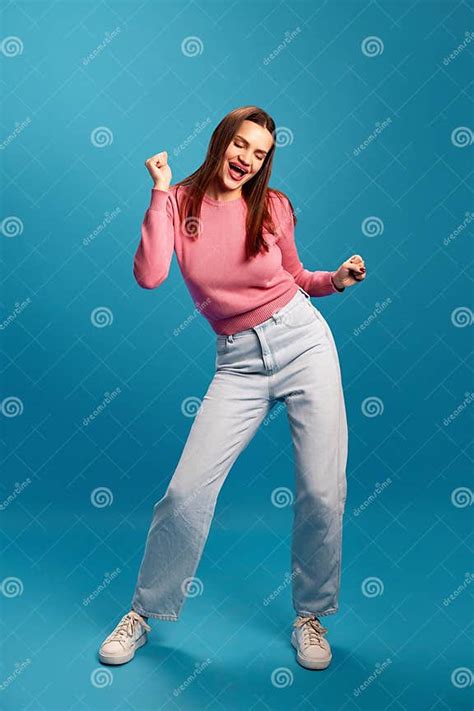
top-left (133, 185), bottom-right (339, 335)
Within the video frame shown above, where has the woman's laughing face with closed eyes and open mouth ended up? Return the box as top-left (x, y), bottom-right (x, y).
top-left (219, 120), bottom-right (273, 190)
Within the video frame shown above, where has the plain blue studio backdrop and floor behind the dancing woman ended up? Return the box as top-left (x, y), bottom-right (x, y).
top-left (0, 0), bottom-right (474, 711)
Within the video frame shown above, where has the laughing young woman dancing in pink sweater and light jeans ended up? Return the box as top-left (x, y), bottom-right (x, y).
top-left (99, 106), bottom-right (365, 669)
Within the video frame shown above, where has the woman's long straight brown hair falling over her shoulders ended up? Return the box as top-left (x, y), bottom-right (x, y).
top-left (171, 106), bottom-right (296, 259)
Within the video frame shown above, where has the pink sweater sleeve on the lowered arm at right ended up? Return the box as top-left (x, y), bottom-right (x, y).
top-left (278, 200), bottom-right (344, 296)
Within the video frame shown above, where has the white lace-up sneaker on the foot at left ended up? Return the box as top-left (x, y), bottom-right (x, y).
top-left (99, 610), bottom-right (151, 664)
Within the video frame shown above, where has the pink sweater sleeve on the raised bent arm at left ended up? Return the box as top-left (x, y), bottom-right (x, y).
top-left (133, 188), bottom-right (174, 289)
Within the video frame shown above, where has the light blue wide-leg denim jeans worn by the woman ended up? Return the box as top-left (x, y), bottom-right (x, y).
top-left (132, 287), bottom-right (348, 620)
